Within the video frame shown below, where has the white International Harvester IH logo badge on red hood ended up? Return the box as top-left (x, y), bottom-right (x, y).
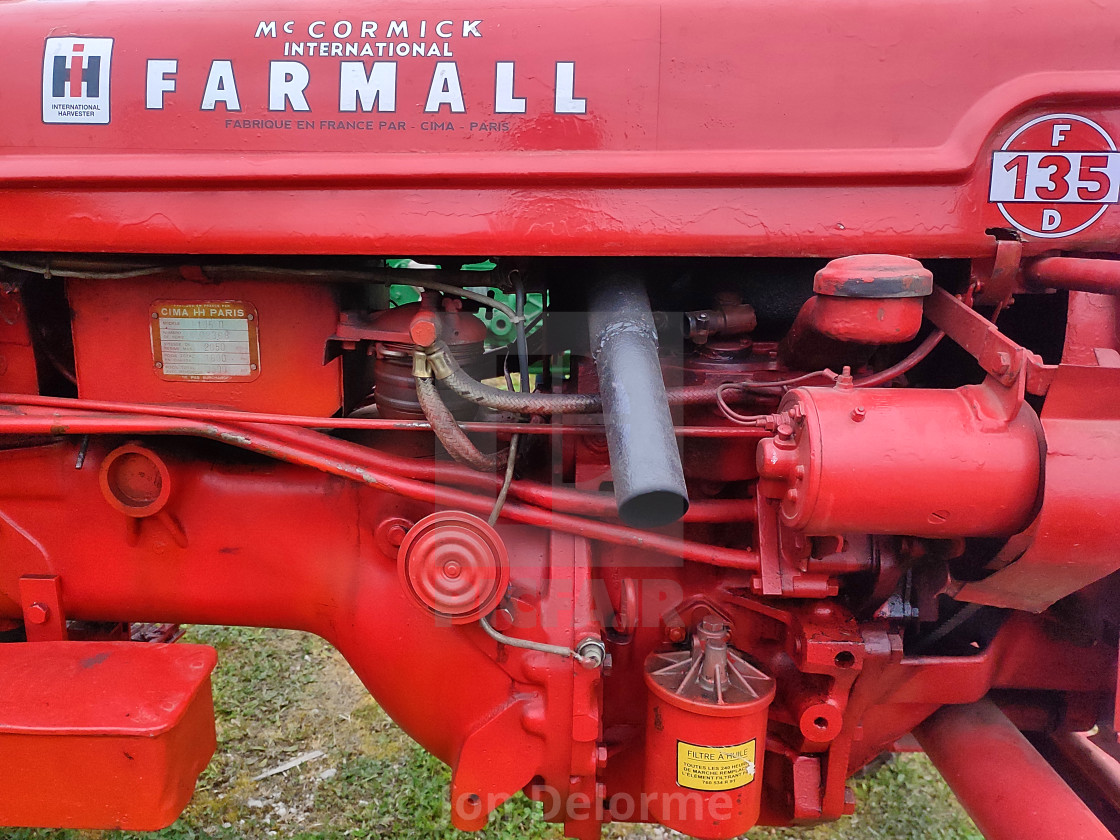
top-left (43, 38), bottom-right (113, 125)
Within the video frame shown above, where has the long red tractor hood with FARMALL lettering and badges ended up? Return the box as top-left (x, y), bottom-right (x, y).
top-left (0, 0), bottom-right (1120, 256)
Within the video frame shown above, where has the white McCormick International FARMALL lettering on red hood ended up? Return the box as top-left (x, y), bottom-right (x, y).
top-left (144, 19), bottom-right (587, 114)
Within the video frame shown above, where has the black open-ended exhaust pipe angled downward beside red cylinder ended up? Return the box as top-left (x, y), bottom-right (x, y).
top-left (588, 272), bottom-right (689, 528)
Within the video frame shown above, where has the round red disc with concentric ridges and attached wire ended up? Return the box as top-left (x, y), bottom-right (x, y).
top-left (398, 511), bottom-right (510, 624)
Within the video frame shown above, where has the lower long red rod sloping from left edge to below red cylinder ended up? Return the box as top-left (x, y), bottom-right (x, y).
top-left (0, 411), bottom-right (759, 571)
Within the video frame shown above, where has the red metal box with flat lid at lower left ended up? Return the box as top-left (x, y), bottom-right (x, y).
top-left (0, 642), bottom-right (217, 830)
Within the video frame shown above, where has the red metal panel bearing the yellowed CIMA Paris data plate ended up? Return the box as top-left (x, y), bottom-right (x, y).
top-left (67, 276), bottom-right (342, 417)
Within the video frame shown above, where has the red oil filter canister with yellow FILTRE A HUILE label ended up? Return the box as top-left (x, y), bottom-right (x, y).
top-left (644, 617), bottom-right (774, 840)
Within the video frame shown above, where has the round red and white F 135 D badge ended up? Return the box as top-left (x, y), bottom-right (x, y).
top-left (989, 114), bottom-right (1120, 239)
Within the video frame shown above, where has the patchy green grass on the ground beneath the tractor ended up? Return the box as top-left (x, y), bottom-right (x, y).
top-left (10, 627), bottom-right (980, 840)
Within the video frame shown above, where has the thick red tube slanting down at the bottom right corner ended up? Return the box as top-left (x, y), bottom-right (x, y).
top-left (914, 700), bottom-right (1114, 840)
